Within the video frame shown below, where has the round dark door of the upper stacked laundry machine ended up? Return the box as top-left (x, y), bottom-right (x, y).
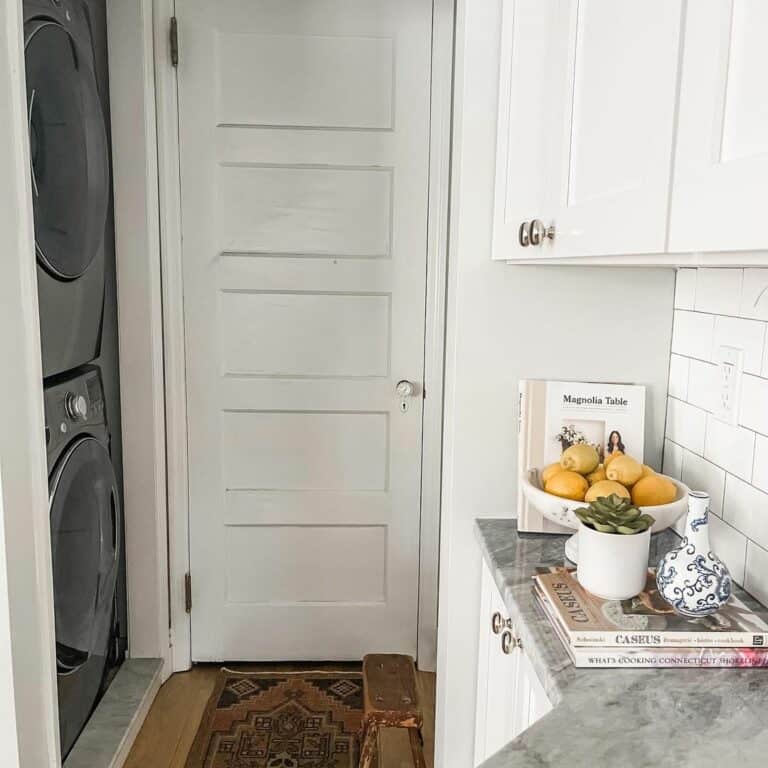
top-left (25, 19), bottom-right (109, 280)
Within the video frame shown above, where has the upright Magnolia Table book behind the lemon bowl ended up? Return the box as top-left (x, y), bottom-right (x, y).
top-left (517, 379), bottom-right (645, 533)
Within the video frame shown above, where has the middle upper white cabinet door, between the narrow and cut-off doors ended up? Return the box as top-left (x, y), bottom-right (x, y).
top-left (548, 0), bottom-right (680, 257)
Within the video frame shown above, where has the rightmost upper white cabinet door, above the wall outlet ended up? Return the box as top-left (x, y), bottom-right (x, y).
top-left (669, 0), bottom-right (768, 251)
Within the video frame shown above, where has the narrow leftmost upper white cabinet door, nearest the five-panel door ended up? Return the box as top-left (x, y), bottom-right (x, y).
top-left (493, 0), bottom-right (564, 260)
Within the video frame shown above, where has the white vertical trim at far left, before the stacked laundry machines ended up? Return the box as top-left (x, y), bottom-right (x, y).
top-left (0, 0), bottom-right (60, 768)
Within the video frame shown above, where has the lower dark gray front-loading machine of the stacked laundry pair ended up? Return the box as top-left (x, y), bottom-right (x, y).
top-left (45, 368), bottom-right (122, 755)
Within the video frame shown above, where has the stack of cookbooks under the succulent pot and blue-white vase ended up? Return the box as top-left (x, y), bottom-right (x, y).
top-left (533, 568), bottom-right (768, 668)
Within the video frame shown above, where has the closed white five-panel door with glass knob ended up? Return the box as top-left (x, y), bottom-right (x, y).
top-left (176, 0), bottom-right (432, 660)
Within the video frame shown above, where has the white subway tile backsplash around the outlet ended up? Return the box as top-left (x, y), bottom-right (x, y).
top-left (664, 269), bottom-right (768, 603)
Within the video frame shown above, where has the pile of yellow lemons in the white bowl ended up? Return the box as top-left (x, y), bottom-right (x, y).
top-left (541, 443), bottom-right (677, 507)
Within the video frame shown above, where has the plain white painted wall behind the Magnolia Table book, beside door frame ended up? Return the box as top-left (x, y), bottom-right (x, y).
top-left (437, 0), bottom-right (674, 768)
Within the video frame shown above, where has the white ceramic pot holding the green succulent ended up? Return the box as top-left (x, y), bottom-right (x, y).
top-left (576, 524), bottom-right (651, 600)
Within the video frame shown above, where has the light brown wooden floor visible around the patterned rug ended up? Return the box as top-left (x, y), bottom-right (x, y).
top-left (125, 664), bottom-right (435, 768)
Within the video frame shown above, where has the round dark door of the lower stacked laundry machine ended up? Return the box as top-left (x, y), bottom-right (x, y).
top-left (50, 437), bottom-right (120, 676)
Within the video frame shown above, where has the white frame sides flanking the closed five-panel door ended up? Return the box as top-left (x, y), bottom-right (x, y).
top-left (156, 0), bottom-right (454, 671)
